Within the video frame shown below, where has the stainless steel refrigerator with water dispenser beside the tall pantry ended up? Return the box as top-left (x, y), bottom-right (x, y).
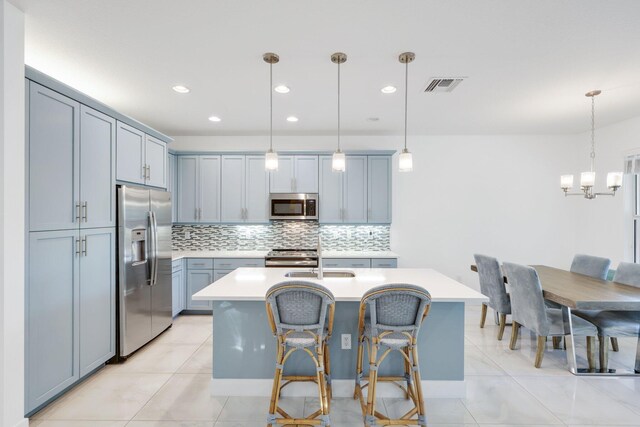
top-left (118, 185), bottom-right (172, 358)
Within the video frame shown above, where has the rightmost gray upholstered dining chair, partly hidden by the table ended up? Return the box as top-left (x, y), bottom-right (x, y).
top-left (574, 262), bottom-right (640, 372)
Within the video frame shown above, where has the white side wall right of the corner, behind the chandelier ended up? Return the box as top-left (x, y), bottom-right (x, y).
top-left (572, 115), bottom-right (640, 267)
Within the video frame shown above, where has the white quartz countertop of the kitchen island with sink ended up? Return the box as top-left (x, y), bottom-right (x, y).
top-left (193, 268), bottom-right (488, 302)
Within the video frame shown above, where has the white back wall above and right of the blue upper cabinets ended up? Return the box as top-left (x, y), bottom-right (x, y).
top-left (171, 135), bottom-right (578, 287)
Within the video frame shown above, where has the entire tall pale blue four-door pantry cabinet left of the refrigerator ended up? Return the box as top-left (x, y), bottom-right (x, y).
top-left (25, 80), bottom-right (116, 413)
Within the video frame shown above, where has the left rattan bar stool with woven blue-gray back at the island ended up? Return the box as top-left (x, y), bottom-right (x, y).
top-left (265, 281), bottom-right (335, 426)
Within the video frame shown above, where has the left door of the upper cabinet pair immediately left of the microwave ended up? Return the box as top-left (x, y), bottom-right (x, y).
top-left (222, 156), bottom-right (248, 222)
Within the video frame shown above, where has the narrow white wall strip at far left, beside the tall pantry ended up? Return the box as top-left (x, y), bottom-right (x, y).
top-left (0, 0), bottom-right (28, 427)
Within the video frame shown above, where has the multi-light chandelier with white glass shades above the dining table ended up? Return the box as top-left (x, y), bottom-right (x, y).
top-left (560, 90), bottom-right (622, 200)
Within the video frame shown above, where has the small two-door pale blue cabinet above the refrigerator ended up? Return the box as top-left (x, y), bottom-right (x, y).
top-left (117, 122), bottom-right (167, 188)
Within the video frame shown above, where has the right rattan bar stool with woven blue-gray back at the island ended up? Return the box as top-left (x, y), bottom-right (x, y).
top-left (353, 284), bottom-right (431, 426)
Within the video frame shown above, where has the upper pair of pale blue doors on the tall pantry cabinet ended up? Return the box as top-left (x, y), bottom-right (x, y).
top-left (28, 82), bottom-right (116, 231)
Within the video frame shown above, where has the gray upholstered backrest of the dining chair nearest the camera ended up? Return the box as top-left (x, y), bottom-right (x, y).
top-left (502, 262), bottom-right (551, 336)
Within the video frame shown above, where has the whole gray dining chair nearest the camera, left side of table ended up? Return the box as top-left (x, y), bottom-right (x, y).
top-left (502, 262), bottom-right (597, 369)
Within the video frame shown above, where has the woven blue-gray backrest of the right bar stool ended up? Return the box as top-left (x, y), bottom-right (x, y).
top-left (360, 283), bottom-right (431, 337)
